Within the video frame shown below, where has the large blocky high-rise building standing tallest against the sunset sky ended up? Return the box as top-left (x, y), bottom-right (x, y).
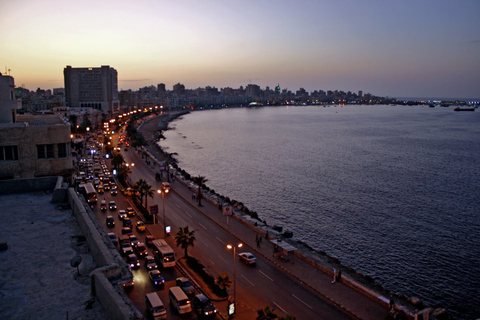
top-left (63, 66), bottom-right (120, 118)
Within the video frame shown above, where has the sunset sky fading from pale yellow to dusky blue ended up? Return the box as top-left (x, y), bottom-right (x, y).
top-left (0, 0), bottom-right (480, 98)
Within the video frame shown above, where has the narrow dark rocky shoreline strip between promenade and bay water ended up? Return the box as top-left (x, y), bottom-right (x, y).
top-left (139, 111), bottom-right (452, 319)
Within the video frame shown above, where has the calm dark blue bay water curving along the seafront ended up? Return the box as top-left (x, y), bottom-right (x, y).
top-left (161, 106), bottom-right (480, 319)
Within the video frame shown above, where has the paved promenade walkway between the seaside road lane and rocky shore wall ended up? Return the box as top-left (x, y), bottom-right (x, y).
top-left (140, 118), bottom-right (389, 320)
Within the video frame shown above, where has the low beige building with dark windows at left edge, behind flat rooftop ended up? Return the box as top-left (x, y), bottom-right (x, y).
top-left (0, 74), bottom-right (73, 179)
